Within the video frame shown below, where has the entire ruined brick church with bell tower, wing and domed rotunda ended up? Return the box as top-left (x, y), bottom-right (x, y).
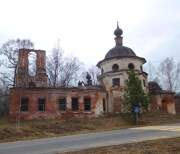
top-left (9, 25), bottom-right (175, 120)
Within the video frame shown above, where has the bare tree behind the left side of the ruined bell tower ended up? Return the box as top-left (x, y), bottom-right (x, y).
top-left (0, 39), bottom-right (34, 86)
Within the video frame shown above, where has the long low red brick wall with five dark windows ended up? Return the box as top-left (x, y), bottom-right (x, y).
top-left (9, 87), bottom-right (107, 120)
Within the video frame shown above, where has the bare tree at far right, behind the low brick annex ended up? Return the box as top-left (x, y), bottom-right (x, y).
top-left (158, 58), bottom-right (180, 91)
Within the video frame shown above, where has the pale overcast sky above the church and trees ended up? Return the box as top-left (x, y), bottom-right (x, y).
top-left (0, 0), bottom-right (180, 65)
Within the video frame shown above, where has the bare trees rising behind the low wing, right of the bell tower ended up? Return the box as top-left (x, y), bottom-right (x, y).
top-left (47, 47), bottom-right (81, 87)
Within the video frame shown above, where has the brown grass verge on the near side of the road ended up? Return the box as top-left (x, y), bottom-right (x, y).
top-left (59, 138), bottom-right (180, 154)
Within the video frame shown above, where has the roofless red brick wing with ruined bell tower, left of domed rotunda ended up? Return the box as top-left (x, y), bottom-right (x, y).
top-left (9, 49), bottom-right (107, 120)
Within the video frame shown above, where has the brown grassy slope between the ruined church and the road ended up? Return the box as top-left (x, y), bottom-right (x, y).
top-left (0, 112), bottom-right (180, 142)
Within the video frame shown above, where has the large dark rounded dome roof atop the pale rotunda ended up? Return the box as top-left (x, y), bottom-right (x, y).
top-left (105, 45), bottom-right (136, 59)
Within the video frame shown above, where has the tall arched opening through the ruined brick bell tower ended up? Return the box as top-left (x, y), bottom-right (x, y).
top-left (28, 52), bottom-right (37, 76)
